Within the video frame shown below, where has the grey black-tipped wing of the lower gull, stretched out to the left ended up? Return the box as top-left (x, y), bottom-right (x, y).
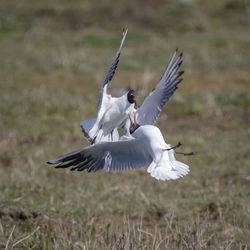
top-left (48, 139), bottom-right (153, 172)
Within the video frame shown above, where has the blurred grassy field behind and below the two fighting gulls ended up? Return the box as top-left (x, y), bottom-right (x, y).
top-left (0, 0), bottom-right (250, 249)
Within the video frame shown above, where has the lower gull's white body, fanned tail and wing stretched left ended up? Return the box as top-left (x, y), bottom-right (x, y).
top-left (48, 125), bottom-right (189, 180)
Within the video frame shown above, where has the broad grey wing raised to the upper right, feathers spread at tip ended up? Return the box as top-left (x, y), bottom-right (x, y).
top-left (136, 50), bottom-right (184, 125)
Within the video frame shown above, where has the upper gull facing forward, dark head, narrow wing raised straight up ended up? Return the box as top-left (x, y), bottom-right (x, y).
top-left (80, 30), bottom-right (136, 143)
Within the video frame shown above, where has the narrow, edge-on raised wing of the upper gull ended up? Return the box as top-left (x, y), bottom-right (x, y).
top-left (97, 29), bottom-right (128, 111)
